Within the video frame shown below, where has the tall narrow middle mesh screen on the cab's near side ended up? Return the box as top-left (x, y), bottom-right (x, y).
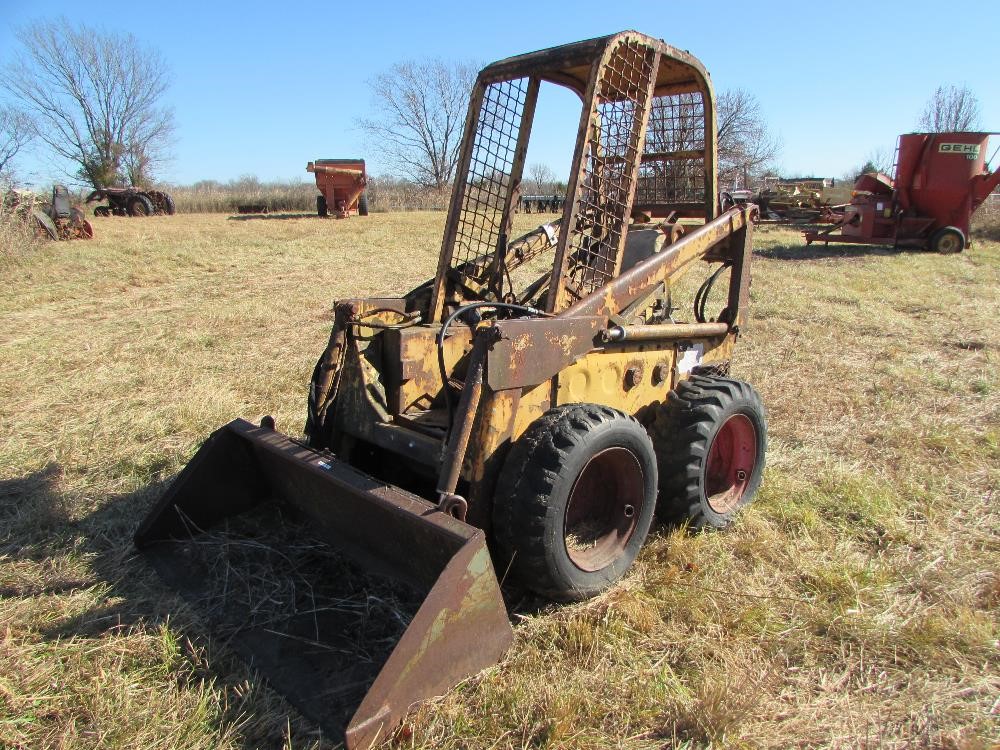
top-left (566, 40), bottom-right (654, 297)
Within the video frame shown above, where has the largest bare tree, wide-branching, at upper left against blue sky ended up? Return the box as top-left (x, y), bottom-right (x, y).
top-left (0, 19), bottom-right (174, 187)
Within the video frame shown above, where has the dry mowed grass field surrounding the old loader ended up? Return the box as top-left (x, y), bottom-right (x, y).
top-left (0, 213), bottom-right (1000, 749)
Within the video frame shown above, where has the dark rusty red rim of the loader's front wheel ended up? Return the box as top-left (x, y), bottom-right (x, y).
top-left (563, 448), bottom-right (646, 572)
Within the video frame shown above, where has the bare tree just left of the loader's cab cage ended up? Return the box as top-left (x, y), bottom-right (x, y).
top-left (358, 60), bottom-right (477, 188)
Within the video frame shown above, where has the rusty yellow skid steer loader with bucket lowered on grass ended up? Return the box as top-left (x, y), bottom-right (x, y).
top-left (136, 31), bottom-right (766, 747)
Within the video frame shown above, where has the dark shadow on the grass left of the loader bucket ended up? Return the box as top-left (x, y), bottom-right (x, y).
top-left (0, 463), bottom-right (338, 750)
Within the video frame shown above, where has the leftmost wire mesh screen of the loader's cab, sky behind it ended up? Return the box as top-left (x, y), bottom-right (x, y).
top-left (451, 78), bottom-right (528, 283)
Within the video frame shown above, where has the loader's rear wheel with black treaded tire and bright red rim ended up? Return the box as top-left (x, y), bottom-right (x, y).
top-left (652, 375), bottom-right (767, 529)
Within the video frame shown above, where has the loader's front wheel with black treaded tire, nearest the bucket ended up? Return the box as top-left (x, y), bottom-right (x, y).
top-left (493, 404), bottom-right (656, 601)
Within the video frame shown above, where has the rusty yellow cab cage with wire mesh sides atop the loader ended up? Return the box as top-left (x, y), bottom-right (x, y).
top-left (428, 31), bottom-right (716, 321)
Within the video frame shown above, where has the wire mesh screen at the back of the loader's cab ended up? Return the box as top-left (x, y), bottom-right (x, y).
top-left (635, 92), bottom-right (705, 206)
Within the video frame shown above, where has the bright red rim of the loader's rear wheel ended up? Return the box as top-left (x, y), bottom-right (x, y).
top-left (705, 414), bottom-right (757, 513)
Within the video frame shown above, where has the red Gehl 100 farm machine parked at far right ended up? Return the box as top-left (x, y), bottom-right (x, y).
top-left (805, 133), bottom-right (1000, 253)
